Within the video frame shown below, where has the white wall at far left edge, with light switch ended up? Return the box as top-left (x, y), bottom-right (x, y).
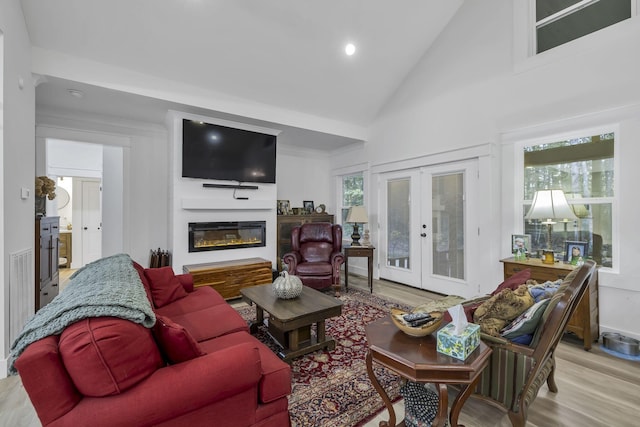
top-left (0, 0), bottom-right (35, 377)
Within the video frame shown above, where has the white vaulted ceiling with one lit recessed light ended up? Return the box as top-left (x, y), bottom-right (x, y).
top-left (22, 0), bottom-right (462, 148)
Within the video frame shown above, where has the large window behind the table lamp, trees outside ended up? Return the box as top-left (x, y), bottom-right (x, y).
top-left (523, 133), bottom-right (615, 267)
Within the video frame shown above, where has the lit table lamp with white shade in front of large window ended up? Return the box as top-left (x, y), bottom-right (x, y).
top-left (524, 190), bottom-right (577, 264)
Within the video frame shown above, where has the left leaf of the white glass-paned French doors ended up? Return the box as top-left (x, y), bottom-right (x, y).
top-left (378, 170), bottom-right (421, 288)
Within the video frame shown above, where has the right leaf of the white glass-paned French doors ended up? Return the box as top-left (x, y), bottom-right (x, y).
top-left (421, 161), bottom-right (478, 296)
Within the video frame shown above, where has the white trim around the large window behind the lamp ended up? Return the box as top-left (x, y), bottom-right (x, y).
top-left (513, 123), bottom-right (623, 273)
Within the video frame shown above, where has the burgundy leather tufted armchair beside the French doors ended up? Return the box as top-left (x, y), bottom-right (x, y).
top-left (282, 222), bottom-right (344, 289)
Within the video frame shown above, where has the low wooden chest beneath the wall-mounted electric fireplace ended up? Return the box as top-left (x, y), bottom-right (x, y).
top-left (182, 258), bottom-right (273, 299)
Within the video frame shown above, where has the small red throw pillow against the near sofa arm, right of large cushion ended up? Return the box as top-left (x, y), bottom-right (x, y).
top-left (153, 315), bottom-right (206, 363)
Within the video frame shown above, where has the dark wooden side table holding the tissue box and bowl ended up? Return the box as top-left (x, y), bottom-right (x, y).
top-left (365, 316), bottom-right (491, 427)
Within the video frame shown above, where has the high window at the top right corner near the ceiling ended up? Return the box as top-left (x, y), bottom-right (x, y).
top-left (535, 0), bottom-right (634, 53)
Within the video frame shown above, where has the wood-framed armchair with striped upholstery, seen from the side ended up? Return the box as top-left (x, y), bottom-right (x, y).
top-left (474, 260), bottom-right (597, 427)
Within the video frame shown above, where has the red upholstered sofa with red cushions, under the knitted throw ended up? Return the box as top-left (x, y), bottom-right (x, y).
top-left (15, 263), bottom-right (291, 427)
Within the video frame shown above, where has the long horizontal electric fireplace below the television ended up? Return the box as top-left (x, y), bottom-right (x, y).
top-left (189, 221), bottom-right (266, 252)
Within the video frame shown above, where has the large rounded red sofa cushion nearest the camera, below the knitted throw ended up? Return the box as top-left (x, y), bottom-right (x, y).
top-left (59, 317), bottom-right (164, 397)
